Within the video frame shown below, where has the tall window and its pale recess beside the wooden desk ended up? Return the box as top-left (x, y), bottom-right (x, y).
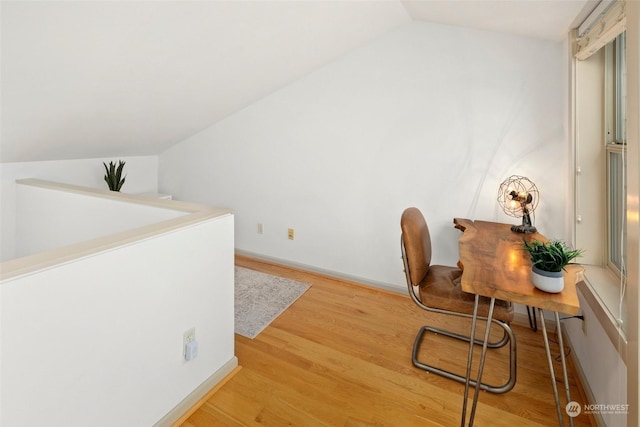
top-left (574, 25), bottom-right (627, 331)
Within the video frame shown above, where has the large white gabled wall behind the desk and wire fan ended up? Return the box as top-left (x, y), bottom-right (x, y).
top-left (159, 23), bottom-right (568, 287)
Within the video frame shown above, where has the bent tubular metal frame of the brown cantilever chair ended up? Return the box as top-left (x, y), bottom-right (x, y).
top-left (400, 236), bottom-right (516, 394)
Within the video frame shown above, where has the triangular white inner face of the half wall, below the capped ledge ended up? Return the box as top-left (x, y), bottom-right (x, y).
top-left (15, 183), bottom-right (187, 257)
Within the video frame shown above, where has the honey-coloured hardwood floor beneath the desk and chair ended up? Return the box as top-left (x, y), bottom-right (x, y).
top-left (182, 256), bottom-right (595, 427)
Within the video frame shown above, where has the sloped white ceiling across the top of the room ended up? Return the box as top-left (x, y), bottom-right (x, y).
top-left (0, 0), bottom-right (597, 162)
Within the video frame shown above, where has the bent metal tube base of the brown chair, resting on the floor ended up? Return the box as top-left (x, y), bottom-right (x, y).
top-left (412, 320), bottom-right (516, 394)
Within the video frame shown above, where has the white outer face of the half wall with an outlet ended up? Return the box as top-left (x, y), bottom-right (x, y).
top-left (0, 215), bottom-right (235, 427)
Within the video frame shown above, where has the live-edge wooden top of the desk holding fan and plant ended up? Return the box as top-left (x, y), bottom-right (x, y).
top-left (453, 218), bottom-right (583, 315)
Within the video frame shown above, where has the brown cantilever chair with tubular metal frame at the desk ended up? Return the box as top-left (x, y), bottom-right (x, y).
top-left (400, 208), bottom-right (516, 393)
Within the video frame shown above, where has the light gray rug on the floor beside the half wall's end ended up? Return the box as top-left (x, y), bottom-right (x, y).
top-left (235, 267), bottom-right (311, 339)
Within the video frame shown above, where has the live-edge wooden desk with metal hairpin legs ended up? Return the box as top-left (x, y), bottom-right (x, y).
top-left (453, 218), bottom-right (583, 426)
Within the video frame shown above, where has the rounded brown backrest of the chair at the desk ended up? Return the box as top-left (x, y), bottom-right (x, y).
top-left (400, 208), bottom-right (431, 286)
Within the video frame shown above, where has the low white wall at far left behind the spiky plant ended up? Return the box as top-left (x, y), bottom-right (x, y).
top-left (0, 156), bottom-right (158, 261)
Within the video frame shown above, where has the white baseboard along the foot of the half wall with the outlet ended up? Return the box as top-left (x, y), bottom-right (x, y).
top-left (154, 356), bottom-right (241, 427)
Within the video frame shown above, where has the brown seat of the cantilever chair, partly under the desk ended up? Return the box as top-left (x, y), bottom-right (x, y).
top-left (417, 265), bottom-right (513, 323)
